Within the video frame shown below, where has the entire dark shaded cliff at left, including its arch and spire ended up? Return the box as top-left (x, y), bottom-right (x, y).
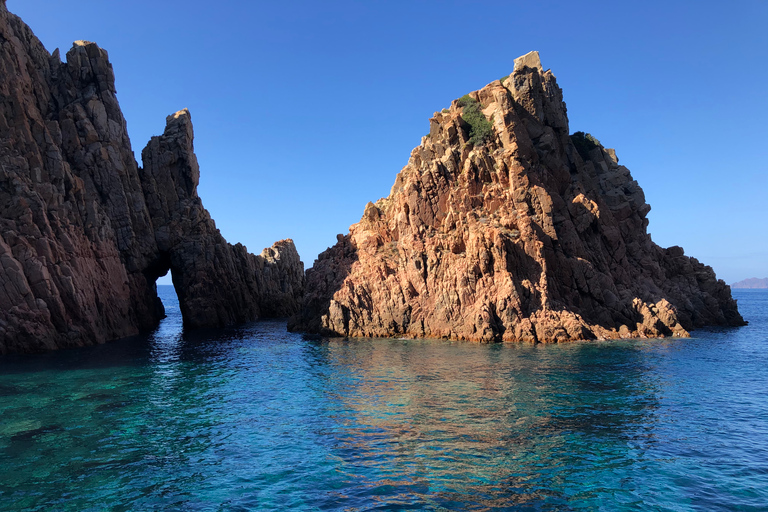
top-left (0, 4), bottom-right (303, 353)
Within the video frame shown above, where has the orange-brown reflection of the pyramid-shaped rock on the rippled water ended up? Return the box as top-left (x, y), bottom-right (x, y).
top-left (304, 340), bottom-right (658, 508)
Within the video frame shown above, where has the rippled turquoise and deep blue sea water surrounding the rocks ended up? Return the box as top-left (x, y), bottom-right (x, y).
top-left (0, 287), bottom-right (768, 511)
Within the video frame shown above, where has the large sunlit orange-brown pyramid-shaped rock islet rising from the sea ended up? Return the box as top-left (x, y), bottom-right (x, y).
top-left (289, 52), bottom-right (744, 342)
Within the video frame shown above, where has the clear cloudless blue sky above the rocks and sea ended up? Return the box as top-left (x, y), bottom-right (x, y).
top-left (7, 0), bottom-right (768, 283)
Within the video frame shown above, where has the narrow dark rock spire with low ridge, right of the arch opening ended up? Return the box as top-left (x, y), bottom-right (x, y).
top-left (139, 110), bottom-right (304, 327)
